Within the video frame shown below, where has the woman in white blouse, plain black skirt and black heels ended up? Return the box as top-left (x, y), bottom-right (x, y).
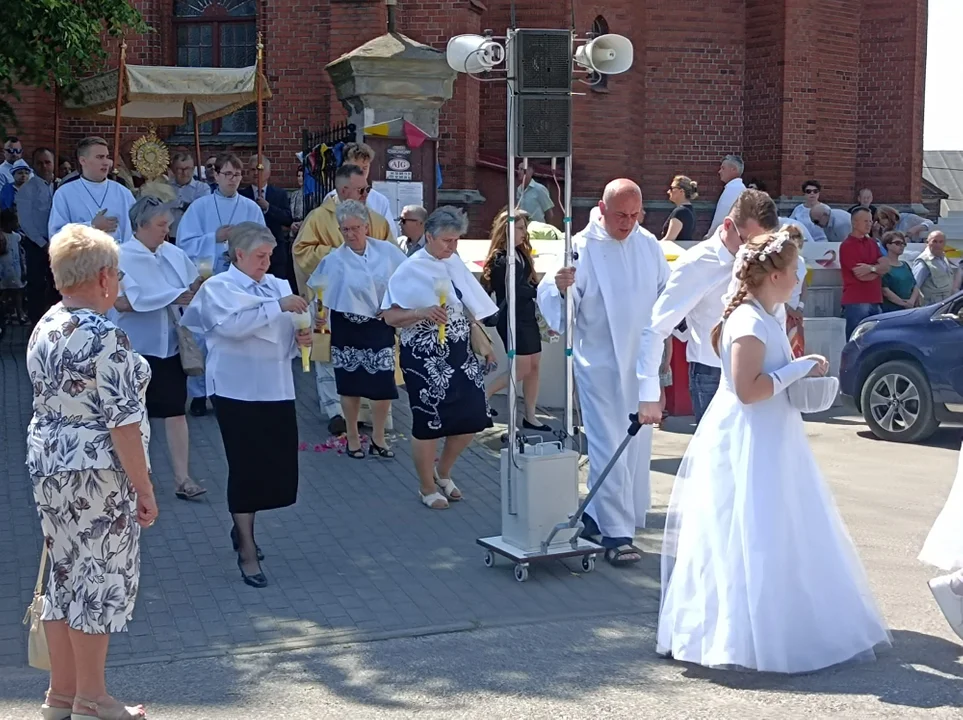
top-left (181, 222), bottom-right (311, 588)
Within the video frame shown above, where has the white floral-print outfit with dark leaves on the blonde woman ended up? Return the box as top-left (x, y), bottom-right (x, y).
top-left (27, 304), bottom-right (150, 634)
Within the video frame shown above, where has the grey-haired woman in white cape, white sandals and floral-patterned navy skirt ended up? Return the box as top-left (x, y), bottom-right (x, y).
top-left (381, 206), bottom-right (498, 510)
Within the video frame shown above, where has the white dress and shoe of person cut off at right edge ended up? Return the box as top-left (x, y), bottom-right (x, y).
top-left (919, 449), bottom-right (963, 639)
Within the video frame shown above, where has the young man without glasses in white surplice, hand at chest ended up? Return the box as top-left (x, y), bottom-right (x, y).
top-left (47, 137), bottom-right (134, 243)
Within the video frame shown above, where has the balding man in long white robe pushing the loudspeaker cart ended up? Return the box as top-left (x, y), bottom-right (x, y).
top-left (538, 179), bottom-right (669, 565)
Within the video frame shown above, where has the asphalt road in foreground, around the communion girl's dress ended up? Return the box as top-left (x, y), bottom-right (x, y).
top-left (0, 408), bottom-right (963, 720)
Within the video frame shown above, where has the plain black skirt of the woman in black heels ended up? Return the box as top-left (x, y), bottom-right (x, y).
top-left (211, 397), bottom-right (298, 513)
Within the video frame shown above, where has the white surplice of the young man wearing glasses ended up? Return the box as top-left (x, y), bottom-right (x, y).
top-left (177, 191), bottom-right (265, 274)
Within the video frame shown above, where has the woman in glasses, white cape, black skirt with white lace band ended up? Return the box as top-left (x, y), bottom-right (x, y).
top-left (308, 200), bottom-right (407, 460)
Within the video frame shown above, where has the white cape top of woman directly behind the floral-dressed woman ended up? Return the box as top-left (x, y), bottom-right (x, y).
top-left (110, 238), bottom-right (197, 358)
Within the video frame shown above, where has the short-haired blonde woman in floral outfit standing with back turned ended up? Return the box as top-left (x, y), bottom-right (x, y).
top-left (27, 224), bottom-right (157, 720)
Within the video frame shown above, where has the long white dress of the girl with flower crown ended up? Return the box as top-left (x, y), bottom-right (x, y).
top-left (658, 301), bottom-right (890, 673)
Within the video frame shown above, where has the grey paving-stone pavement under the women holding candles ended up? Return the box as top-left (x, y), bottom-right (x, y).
top-left (0, 329), bottom-right (658, 666)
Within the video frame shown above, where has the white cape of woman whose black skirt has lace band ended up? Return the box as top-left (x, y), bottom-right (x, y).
top-left (308, 238), bottom-right (408, 318)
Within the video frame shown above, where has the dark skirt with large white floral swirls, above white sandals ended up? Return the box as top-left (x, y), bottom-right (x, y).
top-left (401, 307), bottom-right (492, 440)
